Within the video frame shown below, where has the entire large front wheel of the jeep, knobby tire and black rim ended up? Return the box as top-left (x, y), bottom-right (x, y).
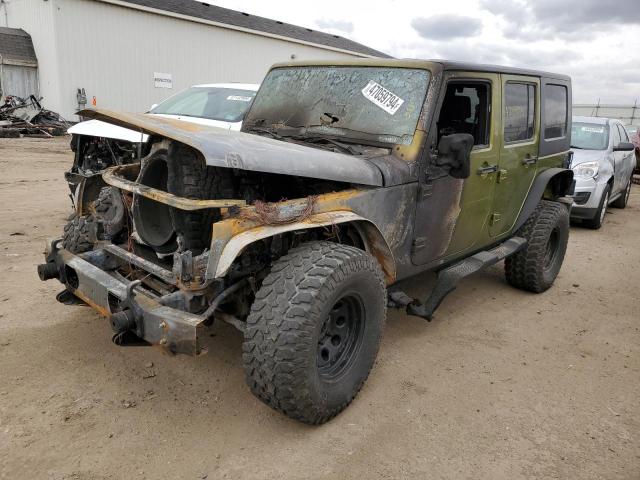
top-left (243, 241), bottom-right (386, 424)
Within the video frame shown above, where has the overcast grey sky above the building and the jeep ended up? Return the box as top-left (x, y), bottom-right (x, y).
top-left (208, 0), bottom-right (640, 104)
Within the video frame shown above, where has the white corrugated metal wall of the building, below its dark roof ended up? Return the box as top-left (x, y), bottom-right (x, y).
top-left (9, 0), bottom-right (362, 120)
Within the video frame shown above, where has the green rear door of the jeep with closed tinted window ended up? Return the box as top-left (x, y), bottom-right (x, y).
top-left (489, 75), bottom-right (540, 237)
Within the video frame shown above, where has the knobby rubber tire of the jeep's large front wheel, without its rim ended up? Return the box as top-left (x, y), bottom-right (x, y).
top-left (242, 241), bottom-right (386, 425)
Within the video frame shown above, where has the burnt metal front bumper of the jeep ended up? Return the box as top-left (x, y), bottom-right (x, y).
top-left (38, 240), bottom-right (206, 355)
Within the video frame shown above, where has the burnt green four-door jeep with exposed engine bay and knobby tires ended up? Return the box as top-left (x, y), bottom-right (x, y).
top-left (38, 59), bottom-right (573, 424)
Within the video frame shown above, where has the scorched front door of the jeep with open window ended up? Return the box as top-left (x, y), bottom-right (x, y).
top-left (412, 72), bottom-right (500, 265)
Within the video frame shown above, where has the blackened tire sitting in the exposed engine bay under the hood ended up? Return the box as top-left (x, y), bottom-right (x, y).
top-left (168, 145), bottom-right (234, 249)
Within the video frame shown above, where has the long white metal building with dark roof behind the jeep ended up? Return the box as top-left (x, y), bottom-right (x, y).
top-left (0, 0), bottom-right (387, 120)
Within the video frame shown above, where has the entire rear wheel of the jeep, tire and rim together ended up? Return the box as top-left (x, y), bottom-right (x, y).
top-left (504, 200), bottom-right (569, 293)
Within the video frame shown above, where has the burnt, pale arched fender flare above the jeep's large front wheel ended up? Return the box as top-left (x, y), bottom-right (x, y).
top-left (212, 211), bottom-right (396, 285)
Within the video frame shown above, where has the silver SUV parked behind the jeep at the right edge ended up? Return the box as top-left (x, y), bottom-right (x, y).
top-left (571, 117), bottom-right (635, 229)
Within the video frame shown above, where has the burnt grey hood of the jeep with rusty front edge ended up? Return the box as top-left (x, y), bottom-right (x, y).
top-left (78, 109), bottom-right (384, 186)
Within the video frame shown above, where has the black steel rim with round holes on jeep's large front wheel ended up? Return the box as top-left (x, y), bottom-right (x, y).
top-left (316, 293), bottom-right (364, 380)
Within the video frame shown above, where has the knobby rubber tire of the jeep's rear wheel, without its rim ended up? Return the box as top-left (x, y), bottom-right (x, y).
top-left (504, 200), bottom-right (569, 293)
